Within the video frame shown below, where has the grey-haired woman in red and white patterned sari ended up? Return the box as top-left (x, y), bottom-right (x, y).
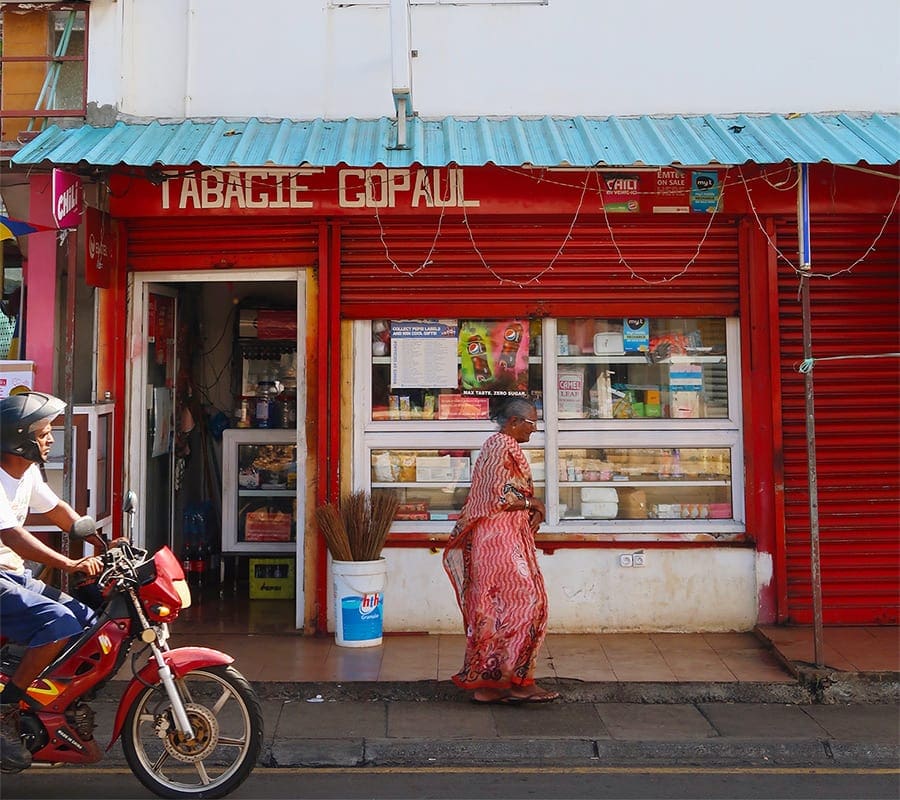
top-left (444, 398), bottom-right (559, 703)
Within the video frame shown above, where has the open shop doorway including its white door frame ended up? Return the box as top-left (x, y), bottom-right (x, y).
top-left (126, 270), bottom-right (306, 633)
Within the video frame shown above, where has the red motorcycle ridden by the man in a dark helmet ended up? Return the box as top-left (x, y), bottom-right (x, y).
top-left (0, 492), bottom-right (263, 798)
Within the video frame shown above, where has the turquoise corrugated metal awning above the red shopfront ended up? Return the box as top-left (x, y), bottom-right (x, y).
top-left (12, 114), bottom-right (900, 167)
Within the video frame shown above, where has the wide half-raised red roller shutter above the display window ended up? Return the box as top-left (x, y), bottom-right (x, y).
top-left (341, 219), bottom-right (739, 319)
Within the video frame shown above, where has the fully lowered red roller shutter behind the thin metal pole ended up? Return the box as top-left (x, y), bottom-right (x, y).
top-left (778, 217), bottom-right (900, 624)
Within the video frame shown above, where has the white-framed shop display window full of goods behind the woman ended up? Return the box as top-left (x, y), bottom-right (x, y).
top-left (354, 316), bottom-right (744, 539)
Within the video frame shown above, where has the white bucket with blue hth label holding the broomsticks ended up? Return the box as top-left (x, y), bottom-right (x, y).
top-left (331, 558), bottom-right (387, 647)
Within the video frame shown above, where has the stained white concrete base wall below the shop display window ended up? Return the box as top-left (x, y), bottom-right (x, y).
top-left (328, 547), bottom-right (768, 633)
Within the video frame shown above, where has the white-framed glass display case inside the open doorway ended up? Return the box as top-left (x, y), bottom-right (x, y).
top-left (222, 428), bottom-right (297, 553)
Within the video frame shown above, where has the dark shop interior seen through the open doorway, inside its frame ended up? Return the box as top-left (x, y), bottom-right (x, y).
top-left (146, 281), bottom-right (298, 633)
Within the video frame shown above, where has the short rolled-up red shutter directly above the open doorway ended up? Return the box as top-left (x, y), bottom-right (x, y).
top-left (126, 216), bottom-right (318, 271)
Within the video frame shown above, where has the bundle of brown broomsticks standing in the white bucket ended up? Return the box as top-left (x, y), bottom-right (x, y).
top-left (316, 491), bottom-right (400, 561)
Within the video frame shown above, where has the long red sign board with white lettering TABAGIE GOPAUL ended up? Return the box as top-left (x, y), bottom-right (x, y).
top-left (110, 165), bottom-right (722, 218)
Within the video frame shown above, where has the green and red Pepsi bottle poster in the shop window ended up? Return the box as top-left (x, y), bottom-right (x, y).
top-left (459, 319), bottom-right (529, 397)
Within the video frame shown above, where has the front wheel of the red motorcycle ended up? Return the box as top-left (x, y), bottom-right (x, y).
top-left (122, 666), bottom-right (263, 798)
